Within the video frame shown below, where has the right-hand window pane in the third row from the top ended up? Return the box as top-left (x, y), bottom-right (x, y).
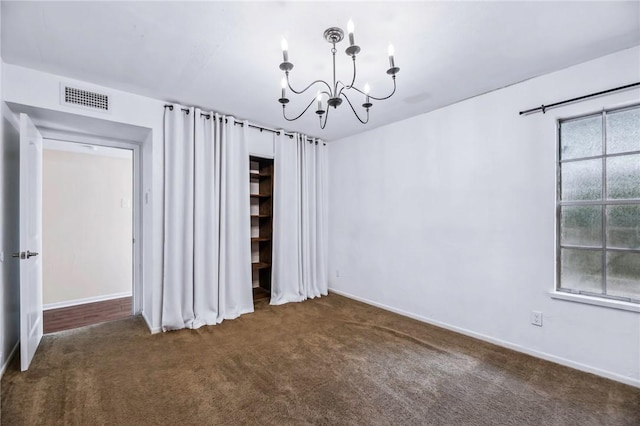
top-left (607, 204), bottom-right (640, 249)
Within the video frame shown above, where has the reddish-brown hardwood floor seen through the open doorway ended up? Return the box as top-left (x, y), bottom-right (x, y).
top-left (43, 297), bottom-right (132, 334)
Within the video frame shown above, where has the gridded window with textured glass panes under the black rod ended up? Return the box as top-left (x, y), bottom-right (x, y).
top-left (556, 105), bottom-right (640, 303)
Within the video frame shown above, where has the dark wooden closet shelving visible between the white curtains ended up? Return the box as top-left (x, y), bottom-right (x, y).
top-left (249, 156), bottom-right (273, 300)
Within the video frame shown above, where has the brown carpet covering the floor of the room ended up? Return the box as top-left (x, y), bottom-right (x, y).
top-left (2, 295), bottom-right (640, 425)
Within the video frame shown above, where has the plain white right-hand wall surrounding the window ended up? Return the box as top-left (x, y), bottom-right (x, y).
top-left (329, 47), bottom-right (640, 386)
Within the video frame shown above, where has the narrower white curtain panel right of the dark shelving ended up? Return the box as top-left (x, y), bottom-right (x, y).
top-left (271, 131), bottom-right (328, 305)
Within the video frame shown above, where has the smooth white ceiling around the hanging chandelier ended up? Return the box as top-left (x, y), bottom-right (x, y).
top-left (1, 1), bottom-right (640, 140)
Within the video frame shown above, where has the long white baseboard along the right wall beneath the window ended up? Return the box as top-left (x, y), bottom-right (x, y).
top-left (329, 288), bottom-right (640, 388)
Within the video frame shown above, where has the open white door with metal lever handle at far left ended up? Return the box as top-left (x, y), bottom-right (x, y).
top-left (14, 114), bottom-right (42, 371)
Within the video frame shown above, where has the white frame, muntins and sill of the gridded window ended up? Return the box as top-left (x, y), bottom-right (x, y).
top-left (551, 104), bottom-right (640, 312)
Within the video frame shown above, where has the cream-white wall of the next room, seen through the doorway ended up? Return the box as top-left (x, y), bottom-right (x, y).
top-left (42, 148), bottom-right (133, 308)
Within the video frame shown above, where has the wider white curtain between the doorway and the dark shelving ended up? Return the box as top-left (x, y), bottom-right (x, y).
top-left (162, 105), bottom-right (253, 330)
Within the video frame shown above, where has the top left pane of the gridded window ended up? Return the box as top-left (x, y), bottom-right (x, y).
top-left (560, 115), bottom-right (602, 160)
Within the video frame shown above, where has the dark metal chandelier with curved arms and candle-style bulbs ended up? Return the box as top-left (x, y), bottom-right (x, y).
top-left (278, 20), bottom-right (400, 129)
